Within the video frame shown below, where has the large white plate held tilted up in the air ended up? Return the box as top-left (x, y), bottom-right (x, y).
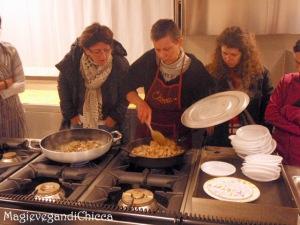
top-left (181, 91), bottom-right (249, 128)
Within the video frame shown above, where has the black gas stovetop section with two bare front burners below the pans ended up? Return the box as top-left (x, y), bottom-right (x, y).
top-left (0, 139), bottom-right (204, 224)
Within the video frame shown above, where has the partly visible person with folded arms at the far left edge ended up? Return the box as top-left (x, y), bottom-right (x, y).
top-left (0, 17), bottom-right (26, 139)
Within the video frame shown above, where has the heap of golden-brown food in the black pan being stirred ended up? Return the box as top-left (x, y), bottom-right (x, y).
top-left (131, 139), bottom-right (183, 158)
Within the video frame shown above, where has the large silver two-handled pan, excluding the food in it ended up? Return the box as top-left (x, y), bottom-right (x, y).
top-left (40, 128), bottom-right (122, 163)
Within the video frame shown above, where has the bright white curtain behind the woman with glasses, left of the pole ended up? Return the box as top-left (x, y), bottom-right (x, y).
top-left (0, 0), bottom-right (174, 72)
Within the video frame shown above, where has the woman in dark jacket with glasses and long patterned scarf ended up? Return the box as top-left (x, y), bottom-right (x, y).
top-left (56, 23), bottom-right (129, 139)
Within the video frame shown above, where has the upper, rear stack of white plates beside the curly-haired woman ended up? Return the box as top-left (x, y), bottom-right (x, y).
top-left (229, 125), bottom-right (276, 158)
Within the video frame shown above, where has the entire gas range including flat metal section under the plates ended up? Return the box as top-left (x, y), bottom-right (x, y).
top-left (0, 140), bottom-right (298, 225)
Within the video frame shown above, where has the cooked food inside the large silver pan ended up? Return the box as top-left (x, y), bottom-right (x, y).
top-left (59, 140), bottom-right (103, 152)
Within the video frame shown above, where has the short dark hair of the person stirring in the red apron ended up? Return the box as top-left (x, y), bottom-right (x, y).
top-left (151, 19), bottom-right (181, 41)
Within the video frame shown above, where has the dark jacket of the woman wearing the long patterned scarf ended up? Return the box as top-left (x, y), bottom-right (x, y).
top-left (56, 40), bottom-right (129, 129)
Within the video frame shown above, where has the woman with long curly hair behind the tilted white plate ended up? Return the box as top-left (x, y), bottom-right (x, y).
top-left (207, 26), bottom-right (273, 146)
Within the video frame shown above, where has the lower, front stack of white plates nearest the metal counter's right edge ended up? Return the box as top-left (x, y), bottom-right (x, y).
top-left (241, 154), bottom-right (282, 182)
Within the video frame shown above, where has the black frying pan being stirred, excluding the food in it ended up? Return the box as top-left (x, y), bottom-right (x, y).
top-left (127, 138), bottom-right (186, 168)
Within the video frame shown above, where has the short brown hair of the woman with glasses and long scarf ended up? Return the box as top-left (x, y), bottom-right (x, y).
top-left (79, 23), bottom-right (113, 48)
